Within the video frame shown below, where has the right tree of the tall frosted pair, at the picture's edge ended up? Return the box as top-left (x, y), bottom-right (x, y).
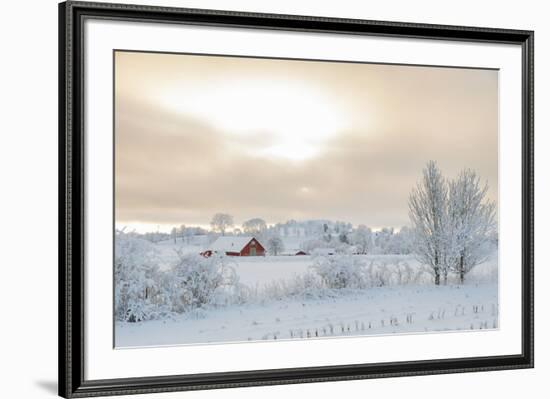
top-left (447, 169), bottom-right (496, 283)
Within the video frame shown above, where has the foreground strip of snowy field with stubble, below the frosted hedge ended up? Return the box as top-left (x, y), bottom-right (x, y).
top-left (115, 283), bottom-right (498, 347)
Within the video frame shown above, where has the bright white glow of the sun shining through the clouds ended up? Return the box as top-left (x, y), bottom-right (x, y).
top-left (155, 77), bottom-right (349, 161)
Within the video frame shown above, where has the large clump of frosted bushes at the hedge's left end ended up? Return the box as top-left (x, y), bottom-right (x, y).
top-left (115, 233), bottom-right (246, 322)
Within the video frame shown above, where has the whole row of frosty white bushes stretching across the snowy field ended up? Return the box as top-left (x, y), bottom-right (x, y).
top-left (115, 233), bottom-right (497, 322)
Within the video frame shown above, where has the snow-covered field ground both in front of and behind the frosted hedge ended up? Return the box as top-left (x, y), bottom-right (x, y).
top-left (115, 242), bottom-right (498, 347)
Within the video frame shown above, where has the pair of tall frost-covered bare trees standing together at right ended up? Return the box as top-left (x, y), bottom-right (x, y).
top-left (409, 161), bottom-right (497, 285)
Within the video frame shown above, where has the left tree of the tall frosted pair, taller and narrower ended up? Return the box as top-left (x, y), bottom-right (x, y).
top-left (409, 161), bottom-right (448, 285)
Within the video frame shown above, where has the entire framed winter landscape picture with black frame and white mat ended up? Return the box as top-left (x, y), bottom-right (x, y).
top-left (59, 2), bottom-right (534, 398)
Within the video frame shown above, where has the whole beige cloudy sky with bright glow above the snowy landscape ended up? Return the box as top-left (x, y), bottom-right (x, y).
top-left (115, 52), bottom-right (498, 231)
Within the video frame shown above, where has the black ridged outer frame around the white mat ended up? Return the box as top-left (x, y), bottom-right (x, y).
top-left (58, 1), bottom-right (534, 398)
